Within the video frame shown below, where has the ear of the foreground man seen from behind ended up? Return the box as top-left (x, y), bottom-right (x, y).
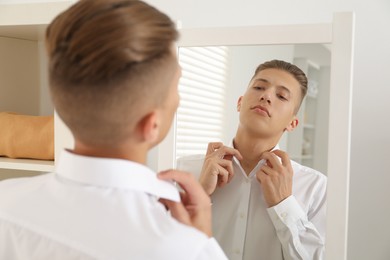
top-left (137, 111), bottom-right (160, 143)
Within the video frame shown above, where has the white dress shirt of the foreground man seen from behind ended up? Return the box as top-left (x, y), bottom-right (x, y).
top-left (0, 151), bottom-right (226, 260)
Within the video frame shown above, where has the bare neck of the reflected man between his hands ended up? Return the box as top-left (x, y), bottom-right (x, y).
top-left (233, 129), bottom-right (280, 175)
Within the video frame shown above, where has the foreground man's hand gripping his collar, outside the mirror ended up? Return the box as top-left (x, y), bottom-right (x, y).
top-left (158, 170), bottom-right (212, 237)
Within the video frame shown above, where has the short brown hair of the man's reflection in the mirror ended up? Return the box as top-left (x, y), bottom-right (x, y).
top-left (254, 60), bottom-right (307, 111)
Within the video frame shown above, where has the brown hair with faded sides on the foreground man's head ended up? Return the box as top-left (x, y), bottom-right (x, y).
top-left (46, 0), bottom-right (178, 146)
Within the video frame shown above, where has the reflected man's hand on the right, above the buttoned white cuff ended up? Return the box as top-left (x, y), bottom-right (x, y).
top-left (256, 150), bottom-right (293, 207)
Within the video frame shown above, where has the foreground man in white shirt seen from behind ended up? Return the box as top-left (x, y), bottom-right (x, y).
top-left (0, 0), bottom-right (226, 260)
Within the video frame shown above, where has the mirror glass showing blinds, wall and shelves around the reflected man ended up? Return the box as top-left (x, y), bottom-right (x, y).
top-left (175, 44), bottom-right (331, 174)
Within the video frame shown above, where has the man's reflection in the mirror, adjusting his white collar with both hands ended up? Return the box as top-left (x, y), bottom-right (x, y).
top-left (178, 60), bottom-right (326, 260)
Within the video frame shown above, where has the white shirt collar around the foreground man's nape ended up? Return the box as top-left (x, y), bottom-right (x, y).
top-left (56, 150), bottom-right (180, 202)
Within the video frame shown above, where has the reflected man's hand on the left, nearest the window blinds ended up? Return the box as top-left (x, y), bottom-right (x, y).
top-left (199, 142), bottom-right (242, 195)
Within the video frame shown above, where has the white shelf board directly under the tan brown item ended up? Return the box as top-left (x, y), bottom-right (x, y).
top-left (0, 157), bottom-right (54, 172)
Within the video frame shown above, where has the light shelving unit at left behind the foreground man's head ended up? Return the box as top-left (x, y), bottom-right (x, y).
top-left (0, 1), bottom-right (75, 179)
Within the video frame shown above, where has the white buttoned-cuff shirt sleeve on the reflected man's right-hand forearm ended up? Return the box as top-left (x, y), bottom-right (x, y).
top-left (267, 195), bottom-right (325, 260)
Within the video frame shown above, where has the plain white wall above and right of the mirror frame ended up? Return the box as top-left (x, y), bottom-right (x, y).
top-left (148, 0), bottom-right (390, 260)
